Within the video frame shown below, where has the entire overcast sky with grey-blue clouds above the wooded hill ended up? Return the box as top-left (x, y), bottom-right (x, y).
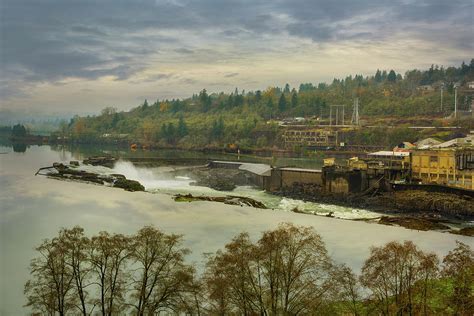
top-left (0, 0), bottom-right (474, 113)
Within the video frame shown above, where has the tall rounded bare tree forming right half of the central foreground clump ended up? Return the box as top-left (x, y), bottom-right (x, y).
top-left (258, 223), bottom-right (334, 315)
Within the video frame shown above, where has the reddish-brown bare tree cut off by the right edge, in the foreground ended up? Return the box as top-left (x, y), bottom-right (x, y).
top-left (442, 241), bottom-right (474, 315)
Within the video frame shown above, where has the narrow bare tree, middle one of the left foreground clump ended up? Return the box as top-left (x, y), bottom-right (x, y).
top-left (90, 232), bottom-right (131, 316)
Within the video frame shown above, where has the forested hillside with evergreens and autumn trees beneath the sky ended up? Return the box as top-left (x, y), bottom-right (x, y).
top-left (57, 59), bottom-right (474, 148)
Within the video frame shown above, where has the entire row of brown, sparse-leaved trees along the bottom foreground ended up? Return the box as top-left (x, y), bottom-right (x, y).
top-left (25, 224), bottom-right (474, 316)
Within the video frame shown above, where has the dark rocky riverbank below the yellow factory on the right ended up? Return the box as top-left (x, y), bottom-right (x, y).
top-left (274, 185), bottom-right (474, 236)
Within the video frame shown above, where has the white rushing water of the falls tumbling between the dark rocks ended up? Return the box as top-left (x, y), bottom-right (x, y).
top-left (103, 161), bottom-right (380, 219)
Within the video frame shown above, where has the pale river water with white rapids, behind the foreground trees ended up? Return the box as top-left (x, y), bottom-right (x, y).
top-left (0, 146), bottom-right (474, 315)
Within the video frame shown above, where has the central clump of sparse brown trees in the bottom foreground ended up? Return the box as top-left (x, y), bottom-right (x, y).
top-left (206, 224), bottom-right (334, 315)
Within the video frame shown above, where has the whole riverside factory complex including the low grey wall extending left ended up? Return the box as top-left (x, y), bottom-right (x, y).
top-left (210, 132), bottom-right (474, 196)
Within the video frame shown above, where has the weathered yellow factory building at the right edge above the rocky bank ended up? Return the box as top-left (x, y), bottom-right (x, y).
top-left (323, 132), bottom-right (474, 193)
